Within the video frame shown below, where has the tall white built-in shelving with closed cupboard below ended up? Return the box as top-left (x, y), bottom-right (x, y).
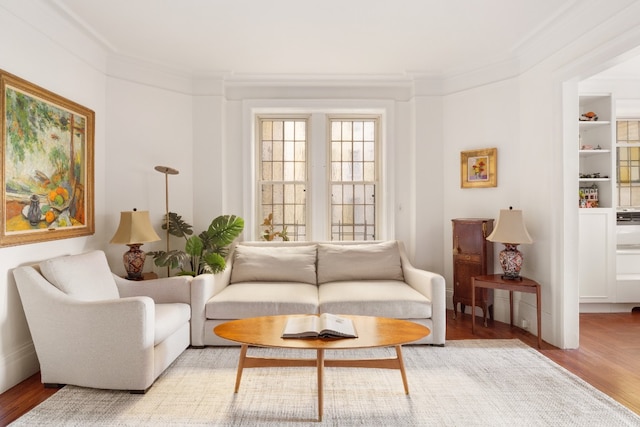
top-left (577, 94), bottom-right (617, 311)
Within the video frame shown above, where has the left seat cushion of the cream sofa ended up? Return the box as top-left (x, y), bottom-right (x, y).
top-left (205, 282), bottom-right (318, 319)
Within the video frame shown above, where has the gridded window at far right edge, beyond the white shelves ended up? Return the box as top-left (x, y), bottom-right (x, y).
top-left (616, 120), bottom-right (640, 207)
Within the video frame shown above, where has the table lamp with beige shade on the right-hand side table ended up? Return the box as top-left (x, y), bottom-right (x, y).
top-left (487, 206), bottom-right (533, 280)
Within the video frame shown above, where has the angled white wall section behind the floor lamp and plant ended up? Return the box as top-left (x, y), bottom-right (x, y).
top-left (104, 77), bottom-right (194, 276)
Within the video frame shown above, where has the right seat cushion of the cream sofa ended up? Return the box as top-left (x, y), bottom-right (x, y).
top-left (318, 280), bottom-right (432, 319)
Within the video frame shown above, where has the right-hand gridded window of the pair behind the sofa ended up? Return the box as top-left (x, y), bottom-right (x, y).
top-left (330, 119), bottom-right (378, 240)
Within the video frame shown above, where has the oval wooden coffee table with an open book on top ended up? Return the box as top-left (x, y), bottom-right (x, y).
top-left (213, 315), bottom-right (431, 421)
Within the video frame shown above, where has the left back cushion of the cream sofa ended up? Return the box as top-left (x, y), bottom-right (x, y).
top-left (230, 245), bottom-right (317, 285)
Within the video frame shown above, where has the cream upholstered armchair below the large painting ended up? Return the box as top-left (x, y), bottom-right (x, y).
top-left (13, 251), bottom-right (191, 393)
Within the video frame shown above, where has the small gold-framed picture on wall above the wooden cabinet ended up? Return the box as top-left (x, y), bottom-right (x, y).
top-left (460, 148), bottom-right (498, 188)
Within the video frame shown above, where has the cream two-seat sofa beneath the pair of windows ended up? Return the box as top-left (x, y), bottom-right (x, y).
top-left (191, 241), bottom-right (446, 346)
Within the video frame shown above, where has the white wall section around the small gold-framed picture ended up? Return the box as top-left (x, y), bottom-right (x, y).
top-left (441, 79), bottom-right (524, 321)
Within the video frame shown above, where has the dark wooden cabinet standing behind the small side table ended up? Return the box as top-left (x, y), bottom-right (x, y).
top-left (451, 218), bottom-right (493, 320)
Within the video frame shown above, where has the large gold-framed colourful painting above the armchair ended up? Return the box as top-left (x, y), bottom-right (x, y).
top-left (0, 70), bottom-right (95, 246)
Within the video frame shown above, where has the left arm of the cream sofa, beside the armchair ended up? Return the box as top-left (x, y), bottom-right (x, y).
top-left (191, 270), bottom-right (231, 347)
